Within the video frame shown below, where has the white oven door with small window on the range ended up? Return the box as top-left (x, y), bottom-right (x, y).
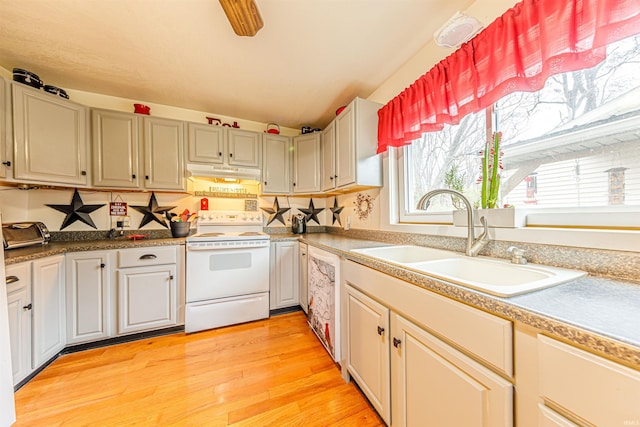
top-left (186, 241), bottom-right (269, 303)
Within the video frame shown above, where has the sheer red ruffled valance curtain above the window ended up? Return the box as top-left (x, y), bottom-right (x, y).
top-left (378, 0), bottom-right (640, 153)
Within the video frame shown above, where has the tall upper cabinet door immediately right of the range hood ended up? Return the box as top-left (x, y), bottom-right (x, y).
top-left (262, 133), bottom-right (291, 194)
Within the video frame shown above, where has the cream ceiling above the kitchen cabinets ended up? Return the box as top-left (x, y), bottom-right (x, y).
top-left (0, 0), bottom-right (473, 128)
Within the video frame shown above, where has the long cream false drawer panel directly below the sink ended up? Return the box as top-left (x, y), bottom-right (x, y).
top-left (342, 261), bottom-right (513, 377)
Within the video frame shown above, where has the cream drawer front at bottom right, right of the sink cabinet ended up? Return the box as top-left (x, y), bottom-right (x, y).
top-left (538, 335), bottom-right (640, 426)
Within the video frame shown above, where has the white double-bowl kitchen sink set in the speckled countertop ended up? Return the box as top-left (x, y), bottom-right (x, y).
top-left (352, 245), bottom-right (587, 297)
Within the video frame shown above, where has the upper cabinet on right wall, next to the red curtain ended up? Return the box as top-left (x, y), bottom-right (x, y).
top-left (323, 98), bottom-right (382, 191)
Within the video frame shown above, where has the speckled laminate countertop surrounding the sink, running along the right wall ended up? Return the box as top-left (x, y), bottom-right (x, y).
top-left (292, 233), bottom-right (640, 369)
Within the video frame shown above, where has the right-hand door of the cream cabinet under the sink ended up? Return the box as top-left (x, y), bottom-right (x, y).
top-left (390, 313), bottom-right (513, 427)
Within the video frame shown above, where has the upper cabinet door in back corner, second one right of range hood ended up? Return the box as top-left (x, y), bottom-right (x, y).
top-left (293, 133), bottom-right (320, 193)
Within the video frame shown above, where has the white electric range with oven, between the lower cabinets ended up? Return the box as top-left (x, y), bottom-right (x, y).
top-left (185, 211), bottom-right (270, 332)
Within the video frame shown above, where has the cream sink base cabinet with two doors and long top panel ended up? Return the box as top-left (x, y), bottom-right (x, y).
top-left (341, 261), bottom-right (513, 427)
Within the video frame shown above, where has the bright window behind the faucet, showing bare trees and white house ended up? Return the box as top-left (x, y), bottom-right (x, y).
top-left (398, 36), bottom-right (640, 227)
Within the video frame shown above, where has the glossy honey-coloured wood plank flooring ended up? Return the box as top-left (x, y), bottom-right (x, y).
top-left (15, 312), bottom-right (384, 427)
